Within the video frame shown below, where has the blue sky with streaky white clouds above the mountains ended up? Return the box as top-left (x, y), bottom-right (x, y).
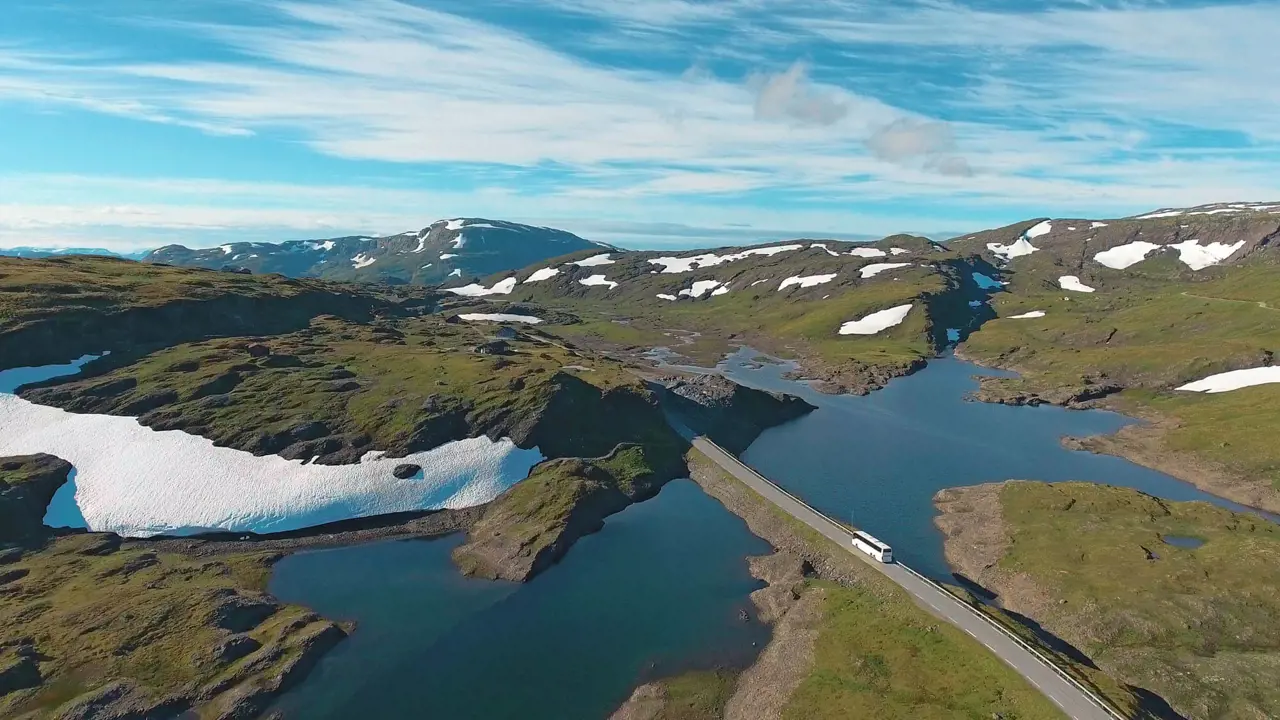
top-left (0, 0), bottom-right (1280, 250)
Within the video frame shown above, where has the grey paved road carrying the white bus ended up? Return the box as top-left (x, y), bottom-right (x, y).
top-left (694, 437), bottom-right (1115, 720)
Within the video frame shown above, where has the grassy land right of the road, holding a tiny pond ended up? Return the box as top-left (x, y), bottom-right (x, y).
top-left (1000, 482), bottom-right (1280, 719)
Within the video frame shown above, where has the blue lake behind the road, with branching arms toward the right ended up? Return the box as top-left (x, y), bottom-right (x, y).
top-left (721, 350), bottom-right (1269, 579)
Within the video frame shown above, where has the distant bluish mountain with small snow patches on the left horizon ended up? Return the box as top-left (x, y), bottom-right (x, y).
top-left (143, 218), bottom-right (608, 284)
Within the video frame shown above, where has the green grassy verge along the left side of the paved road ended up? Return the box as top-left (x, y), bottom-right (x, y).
top-left (690, 452), bottom-right (1062, 720)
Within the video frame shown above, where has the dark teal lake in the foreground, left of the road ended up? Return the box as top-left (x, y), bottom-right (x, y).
top-left (270, 480), bottom-right (769, 720)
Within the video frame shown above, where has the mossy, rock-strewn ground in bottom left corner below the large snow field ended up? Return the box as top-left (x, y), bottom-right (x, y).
top-left (0, 534), bottom-right (337, 716)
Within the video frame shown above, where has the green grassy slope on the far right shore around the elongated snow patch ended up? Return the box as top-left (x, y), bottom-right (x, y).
top-left (963, 263), bottom-right (1280, 489)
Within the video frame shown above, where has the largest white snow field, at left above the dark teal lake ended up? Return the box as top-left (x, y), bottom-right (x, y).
top-left (0, 356), bottom-right (543, 537)
